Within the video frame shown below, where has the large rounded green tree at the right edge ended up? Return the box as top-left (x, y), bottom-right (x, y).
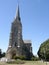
top-left (38, 39), bottom-right (49, 60)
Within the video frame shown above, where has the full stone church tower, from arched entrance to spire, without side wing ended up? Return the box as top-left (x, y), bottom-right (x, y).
top-left (6, 6), bottom-right (23, 58)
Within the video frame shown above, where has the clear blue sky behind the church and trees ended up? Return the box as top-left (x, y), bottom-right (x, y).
top-left (0, 0), bottom-right (49, 55)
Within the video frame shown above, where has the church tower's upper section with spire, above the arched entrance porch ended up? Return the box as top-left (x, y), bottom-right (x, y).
top-left (9, 6), bottom-right (22, 47)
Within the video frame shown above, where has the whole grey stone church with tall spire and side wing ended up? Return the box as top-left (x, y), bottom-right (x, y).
top-left (6, 6), bottom-right (33, 59)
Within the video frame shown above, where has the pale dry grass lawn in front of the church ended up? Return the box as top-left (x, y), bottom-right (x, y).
top-left (0, 61), bottom-right (49, 65)
